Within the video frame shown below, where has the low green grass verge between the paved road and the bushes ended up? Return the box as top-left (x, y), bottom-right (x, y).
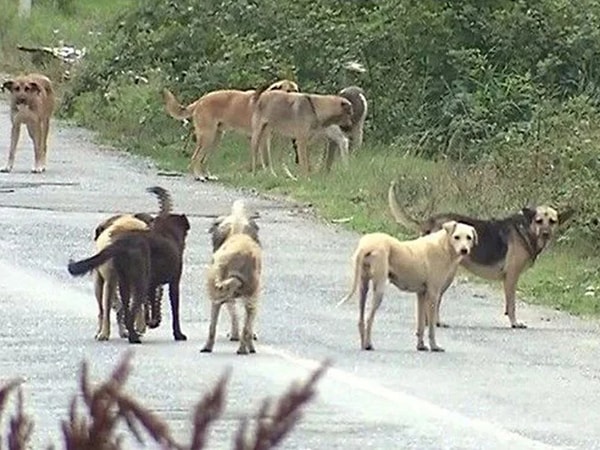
top-left (0, 0), bottom-right (600, 322)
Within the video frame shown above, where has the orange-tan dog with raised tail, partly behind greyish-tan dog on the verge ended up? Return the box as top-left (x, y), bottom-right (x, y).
top-left (163, 80), bottom-right (298, 181)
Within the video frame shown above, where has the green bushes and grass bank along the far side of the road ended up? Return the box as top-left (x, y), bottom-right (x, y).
top-left (3, 0), bottom-right (600, 312)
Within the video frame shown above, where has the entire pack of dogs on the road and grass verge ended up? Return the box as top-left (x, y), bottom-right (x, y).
top-left (2, 73), bottom-right (575, 355)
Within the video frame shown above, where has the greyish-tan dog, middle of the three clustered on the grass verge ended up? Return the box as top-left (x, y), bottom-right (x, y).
top-left (250, 91), bottom-right (353, 175)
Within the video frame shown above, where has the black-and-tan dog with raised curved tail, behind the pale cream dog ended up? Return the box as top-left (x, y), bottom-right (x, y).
top-left (388, 182), bottom-right (575, 328)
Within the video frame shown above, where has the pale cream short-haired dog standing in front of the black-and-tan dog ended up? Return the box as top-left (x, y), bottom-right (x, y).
top-left (338, 221), bottom-right (477, 352)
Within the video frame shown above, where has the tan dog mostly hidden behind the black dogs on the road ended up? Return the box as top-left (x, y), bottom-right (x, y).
top-left (94, 214), bottom-right (148, 341)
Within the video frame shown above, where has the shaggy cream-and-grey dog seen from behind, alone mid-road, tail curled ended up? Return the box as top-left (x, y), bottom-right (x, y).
top-left (202, 200), bottom-right (262, 354)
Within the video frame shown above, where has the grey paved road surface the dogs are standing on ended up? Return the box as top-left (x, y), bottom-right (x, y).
top-left (0, 104), bottom-right (600, 449)
